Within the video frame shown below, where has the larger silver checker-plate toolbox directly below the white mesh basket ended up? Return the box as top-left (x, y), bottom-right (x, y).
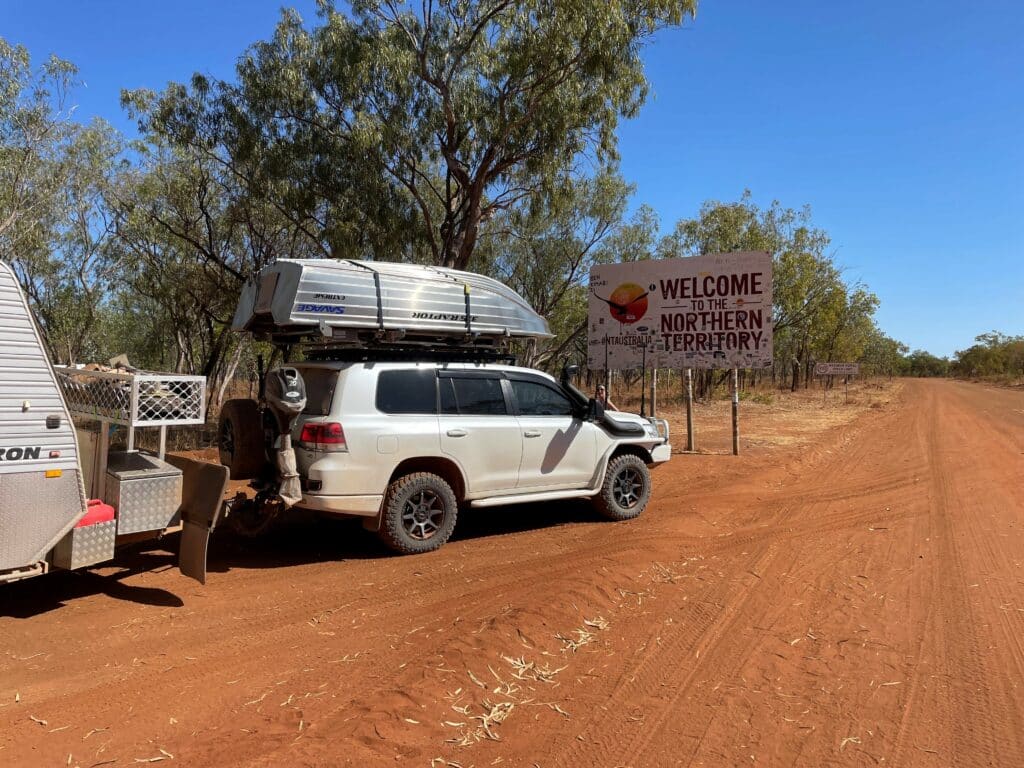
top-left (103, 451), bottom-right (181, 536)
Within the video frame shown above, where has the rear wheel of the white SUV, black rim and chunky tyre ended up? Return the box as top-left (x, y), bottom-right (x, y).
top-left (377, 472), bottom-right (459, 555)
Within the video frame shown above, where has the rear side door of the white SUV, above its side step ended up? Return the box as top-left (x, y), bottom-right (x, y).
top-left (437, 371), bottom-right (523, 496)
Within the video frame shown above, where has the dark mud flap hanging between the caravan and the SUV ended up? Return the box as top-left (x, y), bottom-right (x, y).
top-left (166, 455), bottom-right (228, 584)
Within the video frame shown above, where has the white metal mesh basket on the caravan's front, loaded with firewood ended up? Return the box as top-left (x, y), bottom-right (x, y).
top-left (56, 369), bottom-right (206, 427)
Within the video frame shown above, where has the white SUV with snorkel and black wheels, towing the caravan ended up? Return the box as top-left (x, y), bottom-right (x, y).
top-left (221, 361), bottom-right (672, 553)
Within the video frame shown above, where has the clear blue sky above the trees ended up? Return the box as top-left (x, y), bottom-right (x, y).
top-left (0, 0), bottom-right (1024, 354)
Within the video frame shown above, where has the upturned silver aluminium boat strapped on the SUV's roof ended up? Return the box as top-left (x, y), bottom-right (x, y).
top-left (232, 259), bottom-right (552, 354)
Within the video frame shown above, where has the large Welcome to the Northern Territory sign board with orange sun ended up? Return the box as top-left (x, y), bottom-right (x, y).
top-left (587, 252), bottom-right (772, 370)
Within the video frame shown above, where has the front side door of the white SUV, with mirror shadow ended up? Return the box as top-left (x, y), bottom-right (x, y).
top-left (509, 377), bottom-right (597, 489)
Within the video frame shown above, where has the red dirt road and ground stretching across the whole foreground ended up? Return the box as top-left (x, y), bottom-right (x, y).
top-left (0, 381), bottom-right (1024, 768)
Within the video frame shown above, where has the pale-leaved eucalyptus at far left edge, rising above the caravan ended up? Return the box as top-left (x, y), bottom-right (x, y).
top-left (0, 38), bottom-right (122, 362)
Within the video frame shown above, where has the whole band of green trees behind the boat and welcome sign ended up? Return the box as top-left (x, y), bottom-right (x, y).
top-left (0, 30), bottom-right (942, 396)
